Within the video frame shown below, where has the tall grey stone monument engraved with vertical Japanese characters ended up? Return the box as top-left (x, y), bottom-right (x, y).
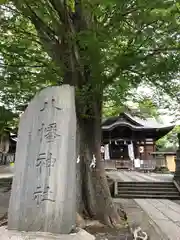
top-left (8, 85), bottom-right (76, 234)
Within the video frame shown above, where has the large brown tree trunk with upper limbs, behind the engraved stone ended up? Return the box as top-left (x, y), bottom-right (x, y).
top-left (13, 0), bottom-right (124, 226)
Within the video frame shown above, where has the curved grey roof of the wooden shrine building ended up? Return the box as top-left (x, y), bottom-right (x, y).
top-left (102, 113), bottom-right (174, 131)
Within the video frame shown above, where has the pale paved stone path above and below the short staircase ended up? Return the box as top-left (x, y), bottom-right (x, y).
top-left (108, 171), bottom-right (180, 240)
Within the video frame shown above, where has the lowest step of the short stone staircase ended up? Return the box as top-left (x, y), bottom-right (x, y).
top-left (114, 194), bottom-right (180, 200)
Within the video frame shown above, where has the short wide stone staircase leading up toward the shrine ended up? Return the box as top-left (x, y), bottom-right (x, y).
top-left (114, 182), bottom-right (180, 200)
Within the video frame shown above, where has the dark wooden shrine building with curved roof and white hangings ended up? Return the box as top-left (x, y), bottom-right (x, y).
top-left (102, 113), bottom-right (174, 168)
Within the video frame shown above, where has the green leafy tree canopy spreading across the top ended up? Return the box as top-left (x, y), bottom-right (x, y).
top-left (0, 0), bottom-right (180, 113)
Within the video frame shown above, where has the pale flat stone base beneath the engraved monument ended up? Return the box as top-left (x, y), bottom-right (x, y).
top-left (0, 226), bottom-right (95, 240)
